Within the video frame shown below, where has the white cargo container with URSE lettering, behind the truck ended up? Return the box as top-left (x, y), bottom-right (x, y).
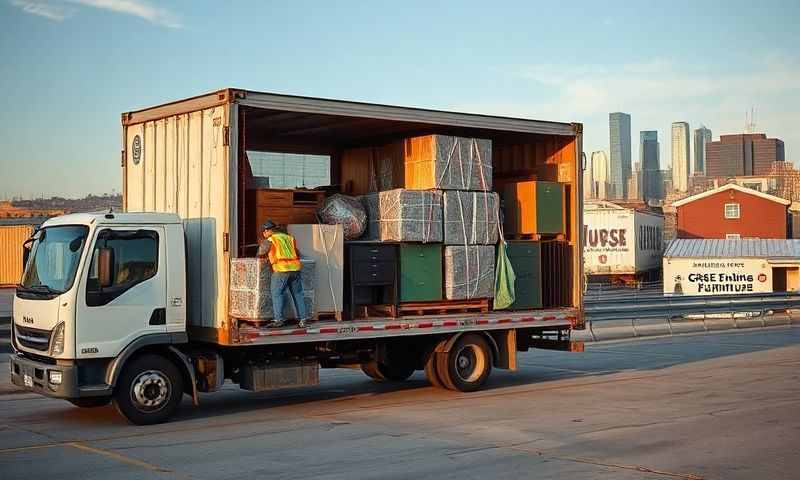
top-left (583, 201), bottom-right (664, 283)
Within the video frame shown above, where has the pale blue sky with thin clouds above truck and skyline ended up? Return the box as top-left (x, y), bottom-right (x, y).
top-left (0, 0), bottom-right (800, 198)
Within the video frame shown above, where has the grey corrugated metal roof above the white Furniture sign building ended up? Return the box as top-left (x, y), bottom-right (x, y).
top-left (664, 238), bottom-right (800, 260)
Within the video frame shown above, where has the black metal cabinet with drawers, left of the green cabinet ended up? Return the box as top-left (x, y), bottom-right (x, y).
top-left (345, 241), bottom-right (399, 318)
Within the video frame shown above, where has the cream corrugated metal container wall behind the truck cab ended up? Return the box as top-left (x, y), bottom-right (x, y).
top-left (123, 103), bottom-right (235, 328)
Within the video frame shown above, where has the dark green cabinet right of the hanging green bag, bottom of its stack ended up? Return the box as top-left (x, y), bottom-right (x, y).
top-left (508, 241), bottom-right (542, 310)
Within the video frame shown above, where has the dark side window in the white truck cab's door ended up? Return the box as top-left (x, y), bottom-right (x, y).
top-left (86, 230), bottom-right (158, 307)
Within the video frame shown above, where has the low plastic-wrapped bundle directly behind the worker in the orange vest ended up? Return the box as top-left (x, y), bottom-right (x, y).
top-left (230, 258), bottom-right (317, 320)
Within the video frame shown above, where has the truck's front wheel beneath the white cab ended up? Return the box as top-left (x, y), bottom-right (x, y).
top-left (114, 354), bottom-right (183, 425)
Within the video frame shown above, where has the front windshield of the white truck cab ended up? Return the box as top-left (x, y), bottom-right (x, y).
top-left (17, 225), bottom-right (89, 297)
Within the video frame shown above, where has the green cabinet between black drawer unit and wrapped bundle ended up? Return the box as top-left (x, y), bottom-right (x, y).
top-left (400, 243), bottom-right (442, 302)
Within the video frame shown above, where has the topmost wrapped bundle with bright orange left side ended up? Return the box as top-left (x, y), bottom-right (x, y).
top-left (404, 135), bottom-right (492, 192)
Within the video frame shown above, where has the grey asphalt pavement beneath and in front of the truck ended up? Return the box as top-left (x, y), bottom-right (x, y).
top-left (0, 327), bottom-right (800, 480)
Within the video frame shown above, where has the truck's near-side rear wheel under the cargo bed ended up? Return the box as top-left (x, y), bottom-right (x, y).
top-left (436, 334), bottom-right (492, 392)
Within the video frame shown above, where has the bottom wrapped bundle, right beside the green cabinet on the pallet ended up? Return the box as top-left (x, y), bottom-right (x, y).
top-left (444, 245), bottom-right (494, 300)
